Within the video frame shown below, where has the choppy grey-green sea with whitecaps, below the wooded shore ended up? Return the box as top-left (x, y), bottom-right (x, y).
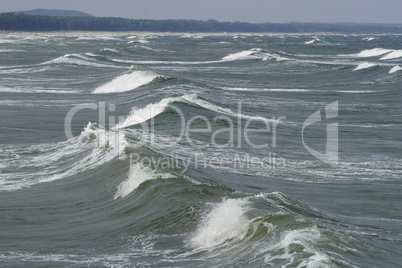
top-left (0, 33), bottom-right (402, 267)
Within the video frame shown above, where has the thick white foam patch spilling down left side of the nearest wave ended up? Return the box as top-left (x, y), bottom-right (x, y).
top-left (189, 199), bottom-right (251, 249)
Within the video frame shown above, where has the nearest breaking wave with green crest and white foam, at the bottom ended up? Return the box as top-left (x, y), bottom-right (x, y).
top-left (187, 193), bottom-right (347, 267)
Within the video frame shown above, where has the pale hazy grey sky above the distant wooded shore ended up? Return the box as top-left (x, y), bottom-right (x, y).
top-left (0, 0), bottom-right (402, 23)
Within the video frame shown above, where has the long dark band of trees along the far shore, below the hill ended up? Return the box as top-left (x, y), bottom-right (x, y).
top-left (0, 13), bottom-right (402, 34)
